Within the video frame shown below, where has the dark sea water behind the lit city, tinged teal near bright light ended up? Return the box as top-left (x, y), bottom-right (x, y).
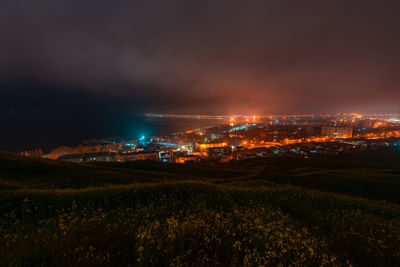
top-left (0, 116), bottom-right (226, 152)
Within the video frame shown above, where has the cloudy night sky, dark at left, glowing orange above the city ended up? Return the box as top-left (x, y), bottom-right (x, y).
top-left (0, 0), bottom-right (400, 150)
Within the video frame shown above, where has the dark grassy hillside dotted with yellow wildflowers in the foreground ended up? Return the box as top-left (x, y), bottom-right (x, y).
top-left (0, 152), bottom-right (400, 266)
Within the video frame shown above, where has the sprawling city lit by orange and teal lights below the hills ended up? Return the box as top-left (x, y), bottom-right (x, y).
top-left (36, 114), bottom-right (400, 163)
